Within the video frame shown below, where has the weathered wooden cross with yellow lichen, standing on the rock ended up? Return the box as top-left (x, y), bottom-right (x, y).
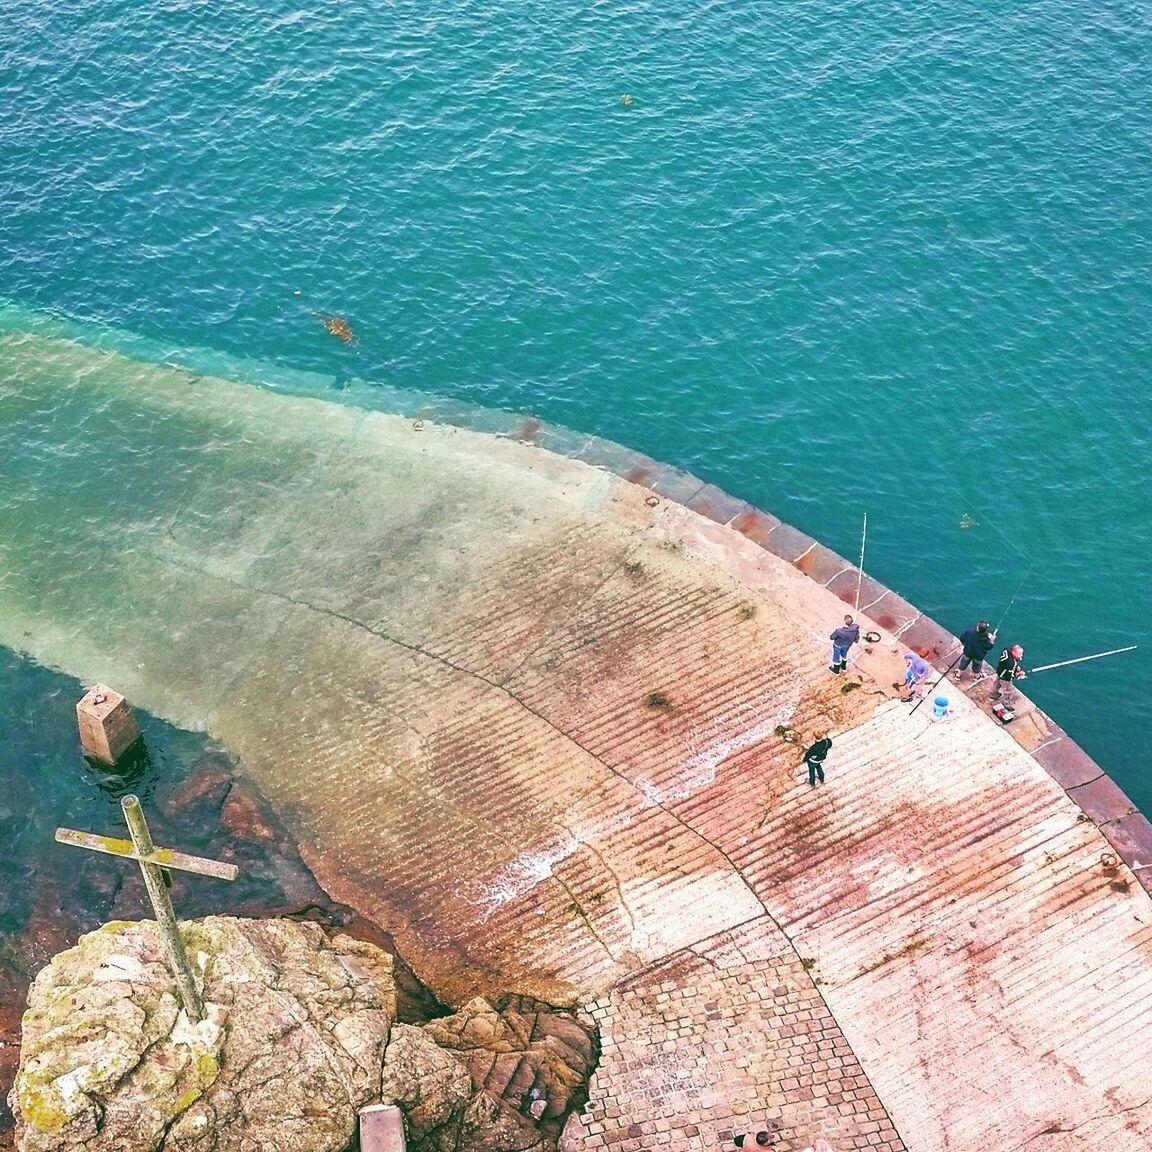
top-left (56, 796), bottom-right (238, 1022)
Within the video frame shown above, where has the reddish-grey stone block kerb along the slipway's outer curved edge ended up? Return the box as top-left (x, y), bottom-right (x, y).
top-left (428, 397), bottom-right (1152, 894)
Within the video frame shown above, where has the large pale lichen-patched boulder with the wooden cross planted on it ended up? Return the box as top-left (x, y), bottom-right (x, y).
top-left (12, 917), bottom-right (395, 1152)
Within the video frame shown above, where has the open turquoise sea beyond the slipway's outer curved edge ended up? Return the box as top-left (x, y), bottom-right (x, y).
top-left (0, 0), bottom-right (1152, 812)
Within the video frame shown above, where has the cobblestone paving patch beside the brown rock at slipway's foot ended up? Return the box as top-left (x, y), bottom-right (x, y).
top-left (561, 917), bottom-right (904, 1152)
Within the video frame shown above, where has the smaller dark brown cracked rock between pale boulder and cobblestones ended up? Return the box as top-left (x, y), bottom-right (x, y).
top-left (381, 996), bottom-right (599, 1152)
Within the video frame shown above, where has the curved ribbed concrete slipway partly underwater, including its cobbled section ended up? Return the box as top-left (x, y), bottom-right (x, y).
top-left (0, 317), bottom-right (1152, 1152)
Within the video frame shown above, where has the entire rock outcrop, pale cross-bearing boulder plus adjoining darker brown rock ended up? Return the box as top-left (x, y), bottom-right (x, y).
top-left (10, 917), bottom-right (599, 1152)
